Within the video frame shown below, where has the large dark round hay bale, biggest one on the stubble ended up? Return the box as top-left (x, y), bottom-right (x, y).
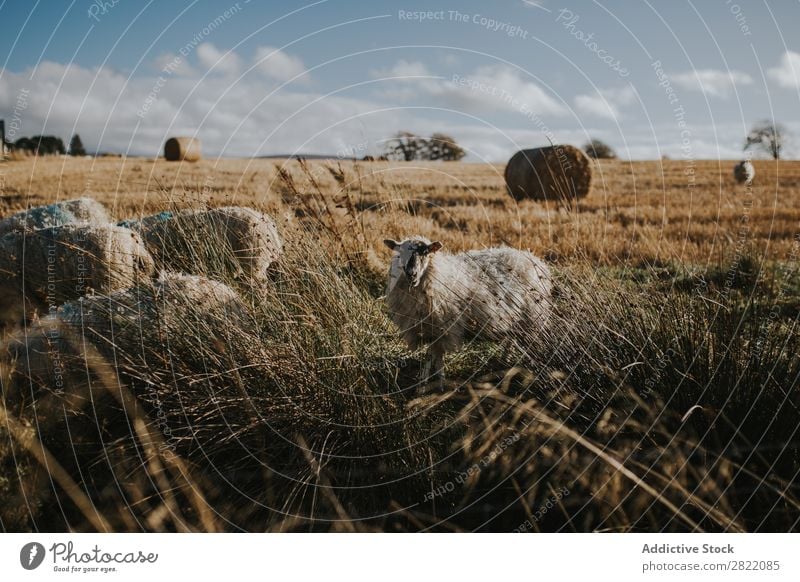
top-left (505, 145), bottom-right (592, 202)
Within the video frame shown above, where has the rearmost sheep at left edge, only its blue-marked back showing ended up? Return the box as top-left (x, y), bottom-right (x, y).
top-left (0, 198), bottom-right (111, 236)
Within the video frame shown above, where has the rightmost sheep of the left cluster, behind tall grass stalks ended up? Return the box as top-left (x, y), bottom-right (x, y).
top-left (120, 206), bottom-right (283, 283)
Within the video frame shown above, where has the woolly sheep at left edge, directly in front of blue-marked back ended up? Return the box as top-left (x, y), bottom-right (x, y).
top-left (0, 224), bottom-right (154, 311)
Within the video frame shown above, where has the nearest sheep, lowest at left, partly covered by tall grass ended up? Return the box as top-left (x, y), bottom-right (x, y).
top-left (8, 272), bottom-right (255, 400)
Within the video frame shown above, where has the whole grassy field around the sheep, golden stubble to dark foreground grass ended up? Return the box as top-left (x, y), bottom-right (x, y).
top-left (0, 158), bottom-right (800, 532)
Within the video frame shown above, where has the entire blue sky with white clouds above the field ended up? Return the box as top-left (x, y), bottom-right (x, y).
top-left (0, 0), bottom-right (800, 162)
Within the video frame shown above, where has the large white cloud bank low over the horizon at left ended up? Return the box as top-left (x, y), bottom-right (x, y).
top-left (0, 62), bottom-right (413, 156)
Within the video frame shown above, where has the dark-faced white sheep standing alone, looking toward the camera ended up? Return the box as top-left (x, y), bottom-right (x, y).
top-left (384, 236), bottom-right (552, 377)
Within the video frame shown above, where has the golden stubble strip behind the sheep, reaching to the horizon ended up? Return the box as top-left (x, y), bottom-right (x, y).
top-left (0, 158), bottom-right (800, 265)
